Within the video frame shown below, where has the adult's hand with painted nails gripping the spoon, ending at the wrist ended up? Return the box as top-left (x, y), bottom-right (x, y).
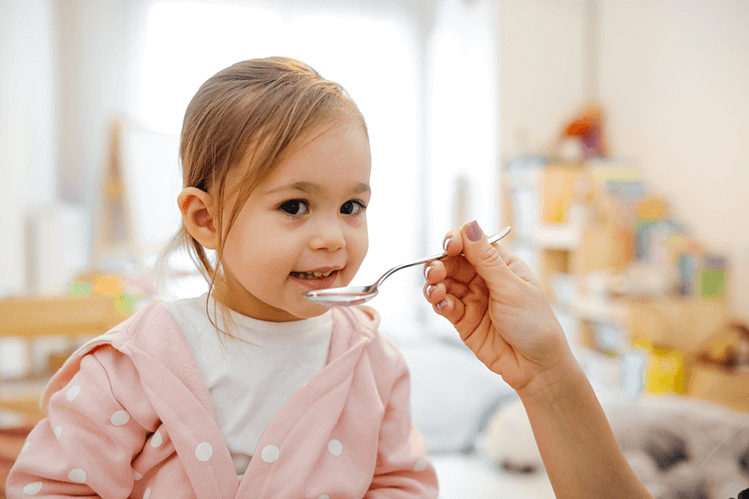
top-left (424, 221), bottom-right (573, 390)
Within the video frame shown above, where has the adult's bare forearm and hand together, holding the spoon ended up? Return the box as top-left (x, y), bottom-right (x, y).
top-left (424, 222), bottom-right (653, 499)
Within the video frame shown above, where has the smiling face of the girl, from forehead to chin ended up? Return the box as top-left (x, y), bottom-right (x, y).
top-left (222, 119), bottom-right (371, 322)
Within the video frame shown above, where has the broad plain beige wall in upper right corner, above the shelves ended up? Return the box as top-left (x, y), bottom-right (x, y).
top-left (599, 0), bottom-right (749, 320)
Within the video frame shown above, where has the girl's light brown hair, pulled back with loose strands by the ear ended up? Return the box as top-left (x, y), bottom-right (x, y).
top-left (165, 57), bottom-right (366, 333)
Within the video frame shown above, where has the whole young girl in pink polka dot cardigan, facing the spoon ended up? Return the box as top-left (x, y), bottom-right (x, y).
top-left (7, 58), bottom-right (437, 499)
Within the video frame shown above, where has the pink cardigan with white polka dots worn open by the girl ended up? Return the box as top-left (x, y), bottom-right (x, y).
top-left (6, 303), bottom-right (437, 499)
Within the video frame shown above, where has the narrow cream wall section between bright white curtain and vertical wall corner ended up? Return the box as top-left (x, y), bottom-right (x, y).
top-left (497, 0), bottom-right (587, 163)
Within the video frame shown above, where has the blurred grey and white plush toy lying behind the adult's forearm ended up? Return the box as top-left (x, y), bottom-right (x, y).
top-left (486, 396), bottom-right (749, 499)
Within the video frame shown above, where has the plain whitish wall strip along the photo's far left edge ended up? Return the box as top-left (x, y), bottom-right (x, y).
top-left (0, 0), bottom-right (58, 296)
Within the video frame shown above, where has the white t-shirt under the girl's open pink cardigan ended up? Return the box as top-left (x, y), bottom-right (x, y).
top-left (167, 294), bottom-right (333, 480)
